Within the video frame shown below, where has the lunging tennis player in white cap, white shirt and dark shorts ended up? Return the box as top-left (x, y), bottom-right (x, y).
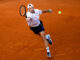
top-left (26, 4), bottom-right (52, 57)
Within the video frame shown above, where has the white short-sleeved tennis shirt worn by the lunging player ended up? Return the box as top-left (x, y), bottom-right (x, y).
top-left (26, 9), bottom-right (42, 27)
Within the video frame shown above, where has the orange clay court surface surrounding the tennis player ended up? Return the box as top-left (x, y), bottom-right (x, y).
top-left (0, 0), bottom-right (80, 60)
